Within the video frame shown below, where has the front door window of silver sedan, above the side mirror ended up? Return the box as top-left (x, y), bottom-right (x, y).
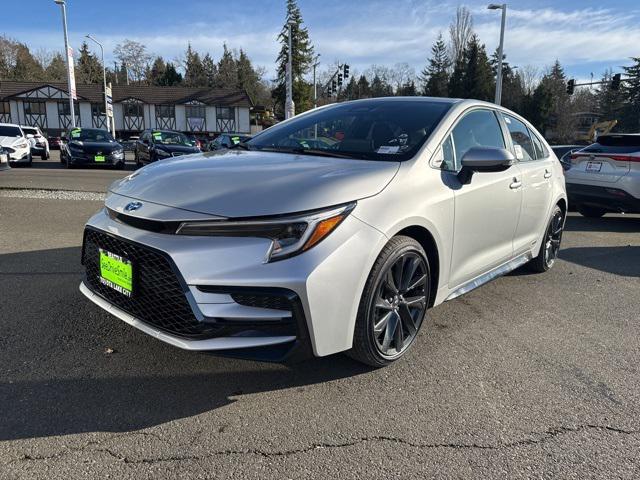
top-left (452, 110), bottom-right (505, 165)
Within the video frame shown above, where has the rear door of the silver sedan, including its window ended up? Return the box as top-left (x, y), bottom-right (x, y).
top-left (503, 115), bottom-right (554, 255)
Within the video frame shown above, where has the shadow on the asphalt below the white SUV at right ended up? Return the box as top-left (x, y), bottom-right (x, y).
top-left (558, 245), bottom-right (640, 277)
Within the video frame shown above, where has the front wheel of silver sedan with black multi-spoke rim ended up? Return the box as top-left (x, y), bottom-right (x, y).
top-left (347, 236), bottom-right (431, 367)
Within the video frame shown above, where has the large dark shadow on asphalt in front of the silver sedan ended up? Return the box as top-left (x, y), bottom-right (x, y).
top-left (0, 247), bottom-right (371, 441)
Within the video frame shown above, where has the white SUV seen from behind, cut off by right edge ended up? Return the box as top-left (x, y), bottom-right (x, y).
top-left (566, 133), bottom-right (640, 217)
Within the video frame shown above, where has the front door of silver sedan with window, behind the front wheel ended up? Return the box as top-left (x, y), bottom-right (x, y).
top-left (442, 108), bottom-right (522, 289)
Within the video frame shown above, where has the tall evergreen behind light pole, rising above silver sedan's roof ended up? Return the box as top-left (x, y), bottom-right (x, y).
top-left (272, 0), bottom-right (313, 112)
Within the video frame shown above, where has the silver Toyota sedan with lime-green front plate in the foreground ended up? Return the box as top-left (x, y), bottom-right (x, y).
top-left (80, 97), bottom-right (567, 366)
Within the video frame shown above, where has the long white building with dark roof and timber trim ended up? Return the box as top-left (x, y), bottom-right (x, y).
top-left (0, 81), bottom-right (252, 138)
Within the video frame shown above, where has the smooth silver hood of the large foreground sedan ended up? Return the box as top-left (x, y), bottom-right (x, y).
top-left (109, 151), bottom-right (400, 217)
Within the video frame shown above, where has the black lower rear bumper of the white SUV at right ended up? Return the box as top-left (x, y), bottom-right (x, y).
top-left (566, 183), bottom-right (640, 213)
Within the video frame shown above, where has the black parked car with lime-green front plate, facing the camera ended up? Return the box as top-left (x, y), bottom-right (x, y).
top-left (60, 128), bottom-right (124, 169)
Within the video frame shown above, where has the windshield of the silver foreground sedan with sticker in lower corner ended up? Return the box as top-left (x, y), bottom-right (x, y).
top-left (246, 99), bottom-right (451, 160)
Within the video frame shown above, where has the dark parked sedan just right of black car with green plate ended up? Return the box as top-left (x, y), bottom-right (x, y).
top-left (133, 129), bottom-right (200, 166)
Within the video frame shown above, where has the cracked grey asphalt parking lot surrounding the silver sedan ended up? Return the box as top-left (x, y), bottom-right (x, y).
top-left (0, 156), bottom-right (640, 479)
